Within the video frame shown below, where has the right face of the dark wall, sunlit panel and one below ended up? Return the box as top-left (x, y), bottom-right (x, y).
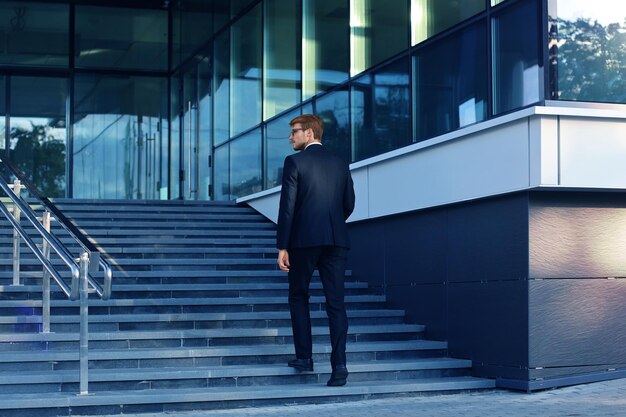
top-left (529, 192), bottom-right (626, 386)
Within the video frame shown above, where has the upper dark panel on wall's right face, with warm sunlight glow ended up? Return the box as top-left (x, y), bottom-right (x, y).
top-left (529, 193), bottom-right (626, 278)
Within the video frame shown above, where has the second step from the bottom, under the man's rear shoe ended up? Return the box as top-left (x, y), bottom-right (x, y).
top-left (0, 358), bottom-right (471, 398)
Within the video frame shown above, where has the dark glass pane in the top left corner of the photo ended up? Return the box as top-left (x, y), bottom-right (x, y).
top-left (0, 1), bottom-right (69, 67)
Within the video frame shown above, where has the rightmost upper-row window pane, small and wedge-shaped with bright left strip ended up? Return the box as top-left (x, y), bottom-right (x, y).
top-left (411, 0), bottom-right (485, 45)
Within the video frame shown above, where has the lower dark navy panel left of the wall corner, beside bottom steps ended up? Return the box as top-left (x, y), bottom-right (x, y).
top-left (448, 281), bottom-right (528, 368)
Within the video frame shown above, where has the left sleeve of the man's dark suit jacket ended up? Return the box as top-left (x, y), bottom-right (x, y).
top-left (276, 157), bottom-right (298, 249)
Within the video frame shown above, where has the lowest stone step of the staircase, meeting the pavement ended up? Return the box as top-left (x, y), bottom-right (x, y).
top-left (0, 376), bottom-right (495, 417)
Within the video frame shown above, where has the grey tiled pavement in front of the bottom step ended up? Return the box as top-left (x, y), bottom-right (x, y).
top-left (100, 378), bottom-right (626, 417)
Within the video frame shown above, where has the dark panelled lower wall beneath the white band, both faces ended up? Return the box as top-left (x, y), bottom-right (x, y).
top-left (349, 191), bottom-right (626, 389)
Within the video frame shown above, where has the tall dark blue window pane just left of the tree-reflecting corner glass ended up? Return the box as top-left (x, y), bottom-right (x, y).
top-left (492, 2), bottom-right (543, 114)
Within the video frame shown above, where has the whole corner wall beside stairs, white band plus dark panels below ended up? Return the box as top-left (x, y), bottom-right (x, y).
top-left (240, 106), bottom-right (626, 390)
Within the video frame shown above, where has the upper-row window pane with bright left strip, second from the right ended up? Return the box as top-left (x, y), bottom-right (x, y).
top-left (350, 0), bottom-right (409, 75)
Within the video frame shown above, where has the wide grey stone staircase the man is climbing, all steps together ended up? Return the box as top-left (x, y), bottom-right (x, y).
top-left (0, 200), bottom-right (495, 417)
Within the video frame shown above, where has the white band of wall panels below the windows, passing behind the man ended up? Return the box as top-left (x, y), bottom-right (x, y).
top-left (238, 106), bottom-right (626, 221)
